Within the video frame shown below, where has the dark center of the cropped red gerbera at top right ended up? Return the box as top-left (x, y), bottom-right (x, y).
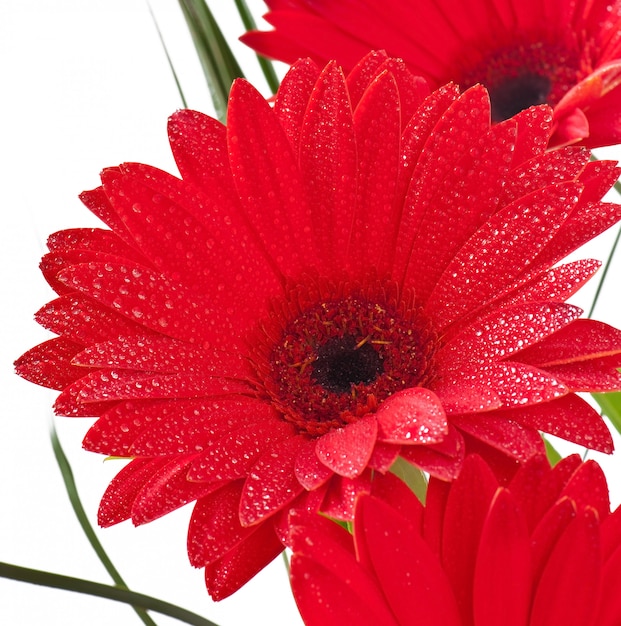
top-left (460, 42), bottom-right (589, 122)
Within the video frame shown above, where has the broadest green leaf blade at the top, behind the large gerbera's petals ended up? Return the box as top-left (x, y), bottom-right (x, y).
top-left (179, 0), bottom-right (243, 123)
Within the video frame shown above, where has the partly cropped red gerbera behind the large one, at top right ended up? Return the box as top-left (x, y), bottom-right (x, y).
top-left (242, 0), bottom-right (621, 148)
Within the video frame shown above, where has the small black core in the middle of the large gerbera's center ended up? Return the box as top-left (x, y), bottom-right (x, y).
top-left (312, 335), bottom-right (384, 393)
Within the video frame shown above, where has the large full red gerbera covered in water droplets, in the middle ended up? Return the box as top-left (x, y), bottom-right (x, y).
top-left (17, 54), bottom-right (621, 598)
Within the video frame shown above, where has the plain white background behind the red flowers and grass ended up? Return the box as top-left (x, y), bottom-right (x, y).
top-left (0, 0), bottom-right (621, 626)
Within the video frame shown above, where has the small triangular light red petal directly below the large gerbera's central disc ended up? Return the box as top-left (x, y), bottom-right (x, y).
top-left (315, 412), bottom-right (378, 478)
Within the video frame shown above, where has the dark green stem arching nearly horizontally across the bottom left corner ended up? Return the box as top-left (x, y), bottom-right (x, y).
top-left (0, 562), bottom-right (218, 626)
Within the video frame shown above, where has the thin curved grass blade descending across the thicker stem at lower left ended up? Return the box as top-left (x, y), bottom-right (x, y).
top-left (50, 421), bottom-right (157, 626)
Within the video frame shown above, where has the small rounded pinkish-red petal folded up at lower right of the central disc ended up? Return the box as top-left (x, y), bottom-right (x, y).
top-left (375, 387), bottom-right (448, 444)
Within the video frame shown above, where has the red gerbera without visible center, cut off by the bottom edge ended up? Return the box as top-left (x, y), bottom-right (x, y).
top-left (290, 455), bottom-right (621, 626)
